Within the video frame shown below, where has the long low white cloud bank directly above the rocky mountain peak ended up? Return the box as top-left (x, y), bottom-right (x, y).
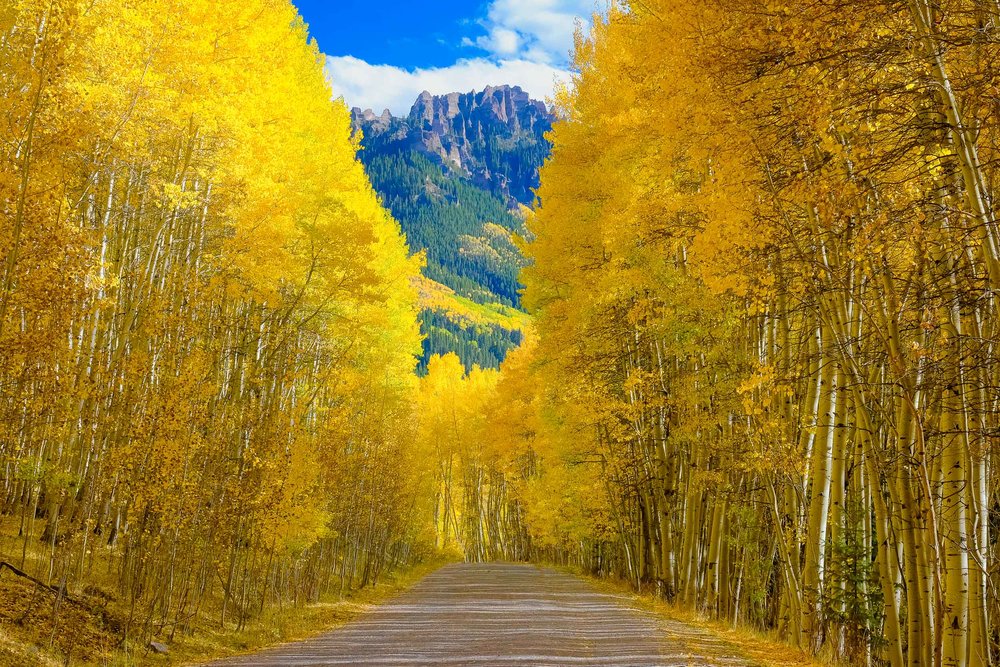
top-left (326, 56), bottom-right (570, 116)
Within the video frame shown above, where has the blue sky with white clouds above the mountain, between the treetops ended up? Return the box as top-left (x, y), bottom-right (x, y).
top-left (293, 0), bottom-right (606, 115)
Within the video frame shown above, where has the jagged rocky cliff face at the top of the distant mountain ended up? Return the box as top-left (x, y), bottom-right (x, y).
top-left (352, 86), bottom-right (555, 206)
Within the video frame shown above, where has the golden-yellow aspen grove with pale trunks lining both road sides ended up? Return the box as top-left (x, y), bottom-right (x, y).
top-left (0, 0), bottom-right (1000, 667)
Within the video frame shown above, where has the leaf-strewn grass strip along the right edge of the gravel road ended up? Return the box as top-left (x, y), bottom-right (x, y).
top-left (576, 568), bottom-right (834, 667)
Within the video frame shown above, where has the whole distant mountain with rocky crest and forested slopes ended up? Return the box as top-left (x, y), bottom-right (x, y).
top-left (352, 86), bottom-right (554, 371)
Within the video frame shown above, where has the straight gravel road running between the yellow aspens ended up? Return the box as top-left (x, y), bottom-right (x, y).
top-left (205, 564), bottom-right (749, 667)
